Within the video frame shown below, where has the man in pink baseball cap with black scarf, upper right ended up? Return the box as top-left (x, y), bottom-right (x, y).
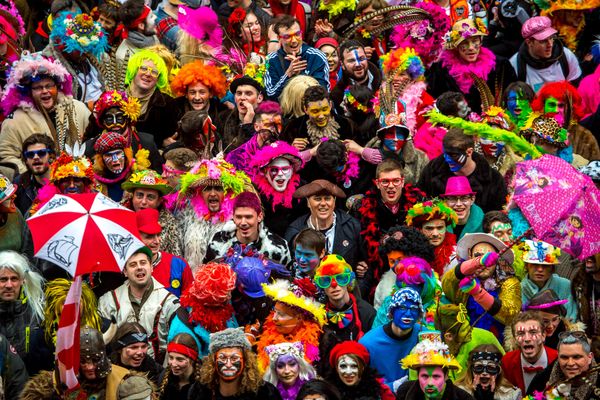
top-left (510, 17), bottom-right (581, 92)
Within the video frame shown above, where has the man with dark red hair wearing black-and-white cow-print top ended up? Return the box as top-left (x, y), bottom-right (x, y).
top-left (204, 192), bottom-right (292, 266)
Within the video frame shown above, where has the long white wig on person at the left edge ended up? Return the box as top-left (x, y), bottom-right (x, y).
top-left (0, 250), bottom-right (45, 321)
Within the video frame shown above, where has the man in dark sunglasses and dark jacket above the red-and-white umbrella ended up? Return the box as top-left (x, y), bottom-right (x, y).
top-left (13, 133), bottom-right (56, 215)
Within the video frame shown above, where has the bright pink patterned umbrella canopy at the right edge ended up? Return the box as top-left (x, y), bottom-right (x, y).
top-left (512, 155), bottom-right (600, 259)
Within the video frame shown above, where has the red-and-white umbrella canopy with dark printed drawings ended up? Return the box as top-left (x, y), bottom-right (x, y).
top-left (27, 193), bottom-right (144, 276)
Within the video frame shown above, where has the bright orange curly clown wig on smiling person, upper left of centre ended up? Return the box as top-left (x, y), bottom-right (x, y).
top-left (171, 61), bottom-right (227, 98)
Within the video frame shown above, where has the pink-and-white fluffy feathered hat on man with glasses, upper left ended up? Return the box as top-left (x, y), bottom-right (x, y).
top-left (2, 51), bottom-right (73, 115)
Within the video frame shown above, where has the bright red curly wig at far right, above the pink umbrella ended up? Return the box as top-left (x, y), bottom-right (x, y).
top-left (531, 81), bottom-right (584, 128)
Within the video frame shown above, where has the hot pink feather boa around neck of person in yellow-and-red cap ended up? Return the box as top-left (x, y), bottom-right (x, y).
top-left (441, 47), bottom-right (496, 93)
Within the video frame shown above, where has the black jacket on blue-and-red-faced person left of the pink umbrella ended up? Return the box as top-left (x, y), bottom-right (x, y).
top-left (417, 153), bottom-right (507, 212)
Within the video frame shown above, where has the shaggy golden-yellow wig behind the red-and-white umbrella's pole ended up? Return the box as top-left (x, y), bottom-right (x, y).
top-left (42, 278), bottom-right (101, 345)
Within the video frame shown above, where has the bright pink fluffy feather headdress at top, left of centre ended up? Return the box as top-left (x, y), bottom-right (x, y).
top-left (177, 6), bottom-right (223, 49)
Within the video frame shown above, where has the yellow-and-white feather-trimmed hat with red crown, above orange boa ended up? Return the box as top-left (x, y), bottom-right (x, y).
top-left (262, 278), bottom-right (327, 326)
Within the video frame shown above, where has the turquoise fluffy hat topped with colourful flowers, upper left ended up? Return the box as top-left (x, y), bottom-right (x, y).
top-left (50, 12), bottom-right (108, 60)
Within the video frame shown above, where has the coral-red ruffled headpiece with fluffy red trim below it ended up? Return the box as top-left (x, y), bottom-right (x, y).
top-left (180, 262), bottom-right (236, 333)
